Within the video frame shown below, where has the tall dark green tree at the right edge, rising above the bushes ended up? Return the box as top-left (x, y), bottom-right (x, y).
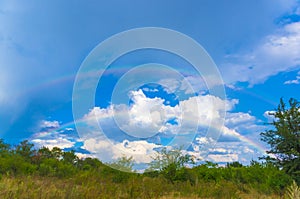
top-left (261, 98), bottom-right (300, 183)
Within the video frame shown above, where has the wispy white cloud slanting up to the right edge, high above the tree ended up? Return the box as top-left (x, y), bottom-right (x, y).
top-left (221, 22), bottom-right (300, 85)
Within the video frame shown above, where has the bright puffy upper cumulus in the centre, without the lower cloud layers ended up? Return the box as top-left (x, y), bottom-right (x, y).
top-left (84, 90), bottom-right (237, 141)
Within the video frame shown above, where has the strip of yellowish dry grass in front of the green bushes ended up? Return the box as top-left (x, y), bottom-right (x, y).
top-left (0, 176), bottom-right (290, 199)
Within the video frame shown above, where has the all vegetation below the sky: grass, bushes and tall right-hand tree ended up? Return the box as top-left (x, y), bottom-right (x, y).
top-left (0, 97), bottom-right (300, 198)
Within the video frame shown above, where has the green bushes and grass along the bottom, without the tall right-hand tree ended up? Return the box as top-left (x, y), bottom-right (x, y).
top-left (0, 140), bottom-right (293, 198)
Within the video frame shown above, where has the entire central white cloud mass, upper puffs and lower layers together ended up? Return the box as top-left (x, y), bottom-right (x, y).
top-left (78, 90), bottom-right (268, 166)
